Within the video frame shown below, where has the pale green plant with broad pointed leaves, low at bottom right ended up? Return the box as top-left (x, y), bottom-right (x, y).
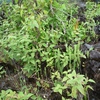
top-left (52, 70), bottom-right (95, 98)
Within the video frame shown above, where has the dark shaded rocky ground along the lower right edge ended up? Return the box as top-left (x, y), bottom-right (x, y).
top-left (82, 42), bottom-right (100, 100)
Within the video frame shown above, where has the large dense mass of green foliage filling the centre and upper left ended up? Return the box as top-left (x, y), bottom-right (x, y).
top-left (0, 0), bottom-right (85, 76)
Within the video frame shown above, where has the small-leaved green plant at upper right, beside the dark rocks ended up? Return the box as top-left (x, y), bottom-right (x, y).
top-left (84, 2), bottom-right (100, 41)
